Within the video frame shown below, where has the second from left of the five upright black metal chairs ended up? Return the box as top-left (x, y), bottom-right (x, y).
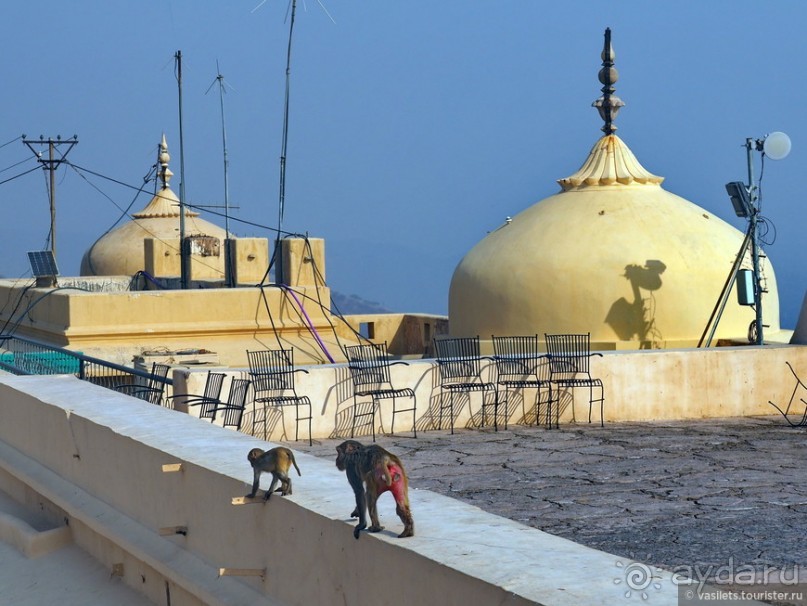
top-left (345, 342), bottom-right (417, 442)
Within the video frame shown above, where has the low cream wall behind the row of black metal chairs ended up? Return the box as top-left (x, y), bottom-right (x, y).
top-left (174, 345), bottom-right (807, 440)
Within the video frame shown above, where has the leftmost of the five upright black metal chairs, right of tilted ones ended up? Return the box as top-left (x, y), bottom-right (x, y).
top-left (247, 349), bottom-right (312, 445)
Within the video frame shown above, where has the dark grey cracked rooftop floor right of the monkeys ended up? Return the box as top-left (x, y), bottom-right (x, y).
top-left (285, 417), bottom-right (807, 579)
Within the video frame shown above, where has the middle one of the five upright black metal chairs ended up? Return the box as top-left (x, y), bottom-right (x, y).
top-left (434, 336), bottom-right (499, 433)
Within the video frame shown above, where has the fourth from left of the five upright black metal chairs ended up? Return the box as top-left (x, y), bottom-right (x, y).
top-left (491, 335), bottom-right (552, 429)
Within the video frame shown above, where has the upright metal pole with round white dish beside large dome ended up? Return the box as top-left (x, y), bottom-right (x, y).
top-left (726, 132), bottom-right (790, 345)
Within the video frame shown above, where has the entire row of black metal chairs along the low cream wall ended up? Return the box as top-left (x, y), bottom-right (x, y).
top-left (118, 334), bottom-right (605, 444)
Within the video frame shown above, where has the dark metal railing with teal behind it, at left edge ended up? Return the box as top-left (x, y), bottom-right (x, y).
top-left (0, 335), bottom-right (173, 396)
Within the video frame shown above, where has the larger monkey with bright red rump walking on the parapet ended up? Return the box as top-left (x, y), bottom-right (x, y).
top-left (336, 440), bottom-right (415, 539)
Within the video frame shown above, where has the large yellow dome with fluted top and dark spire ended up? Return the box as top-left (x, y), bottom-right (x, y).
top-left (449, 32), bottom-right (779, 349)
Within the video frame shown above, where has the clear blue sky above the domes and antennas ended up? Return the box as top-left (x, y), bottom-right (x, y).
top-left (0, 0), bottom-right (807, 328)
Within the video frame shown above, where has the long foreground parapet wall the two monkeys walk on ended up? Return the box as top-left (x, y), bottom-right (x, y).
top-left (0, 376), bottom-right (675, 606)
